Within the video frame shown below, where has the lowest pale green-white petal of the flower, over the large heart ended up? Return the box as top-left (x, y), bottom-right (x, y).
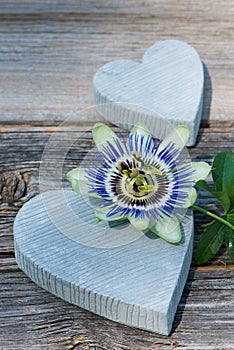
top-left (150, 216), bottom-right (182, 243)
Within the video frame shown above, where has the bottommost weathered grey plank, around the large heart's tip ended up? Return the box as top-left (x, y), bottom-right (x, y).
top-left (0, 259), bottom-right (234, 350)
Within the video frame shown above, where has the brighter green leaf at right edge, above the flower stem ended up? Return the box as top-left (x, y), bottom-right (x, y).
top-left (212, 151), bottom-right (234, 203)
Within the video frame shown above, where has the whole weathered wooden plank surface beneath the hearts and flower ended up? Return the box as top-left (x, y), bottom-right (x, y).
top-left (0, 0), bottom-right (234, 350)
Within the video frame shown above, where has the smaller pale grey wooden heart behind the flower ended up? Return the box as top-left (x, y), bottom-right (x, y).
top-left (93, 40), bottom-right (204, 146)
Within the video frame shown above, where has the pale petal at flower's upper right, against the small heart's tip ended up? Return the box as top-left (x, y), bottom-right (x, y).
top-left (158, 125), bottom-right (190, 153)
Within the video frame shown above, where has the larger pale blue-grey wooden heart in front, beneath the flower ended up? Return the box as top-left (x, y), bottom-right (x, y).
top-left (14, 190), bottom-right (193, 335)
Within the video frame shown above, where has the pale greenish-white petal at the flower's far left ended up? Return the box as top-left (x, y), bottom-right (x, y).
top-left (67, 168), bottom-right (99, 198)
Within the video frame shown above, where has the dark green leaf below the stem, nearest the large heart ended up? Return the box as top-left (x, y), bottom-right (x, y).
top-left (194, 221), bottom-right (225, 265)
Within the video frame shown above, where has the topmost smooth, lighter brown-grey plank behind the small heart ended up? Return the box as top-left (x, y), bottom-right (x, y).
top-left (0, 0), bottom-right (234, 121)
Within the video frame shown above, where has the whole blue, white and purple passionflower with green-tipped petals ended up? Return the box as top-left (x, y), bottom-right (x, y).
top-left (67, 123), bottom-right (210, 243)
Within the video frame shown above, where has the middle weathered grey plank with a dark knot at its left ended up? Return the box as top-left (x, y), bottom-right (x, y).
top-left (0, 123), bottom-right (234, 263)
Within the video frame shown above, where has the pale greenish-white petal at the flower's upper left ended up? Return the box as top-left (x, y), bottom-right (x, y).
top-left (92, 123), bottom-right (121, 152)
